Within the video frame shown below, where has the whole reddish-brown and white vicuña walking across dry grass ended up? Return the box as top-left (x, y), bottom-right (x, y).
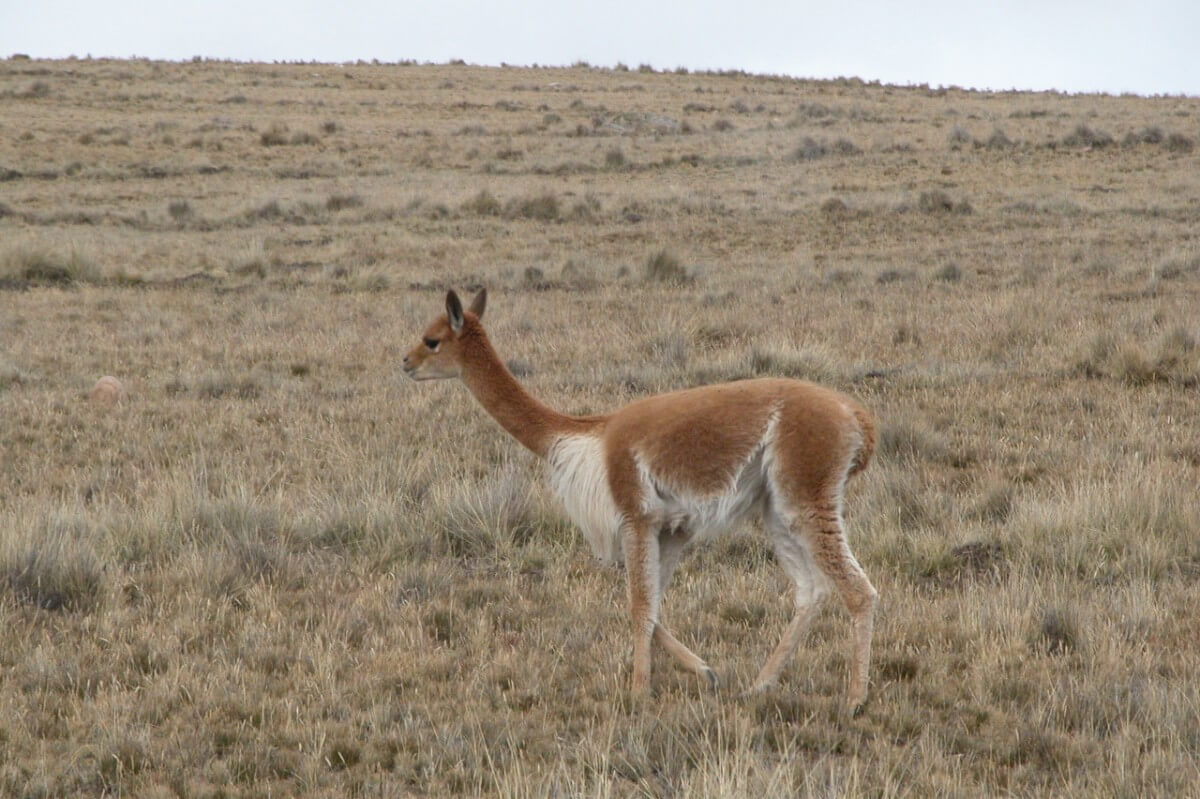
top-left (404, 292), bottom-right (877, 710)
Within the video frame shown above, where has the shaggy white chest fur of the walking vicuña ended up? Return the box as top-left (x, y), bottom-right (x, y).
top-left (546, 435), bottom-right (620, 561)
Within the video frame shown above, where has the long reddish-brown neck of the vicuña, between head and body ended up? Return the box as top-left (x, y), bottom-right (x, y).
top-left (461, 319), bottom-right (598, 457)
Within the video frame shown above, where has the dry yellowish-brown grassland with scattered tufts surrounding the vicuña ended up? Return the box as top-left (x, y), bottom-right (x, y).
top-left (0, 59), bottom-right (1200, 798)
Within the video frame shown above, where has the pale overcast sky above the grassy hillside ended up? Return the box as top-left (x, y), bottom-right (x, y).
top-left (0, 0), bottom-right (1200, 95)
